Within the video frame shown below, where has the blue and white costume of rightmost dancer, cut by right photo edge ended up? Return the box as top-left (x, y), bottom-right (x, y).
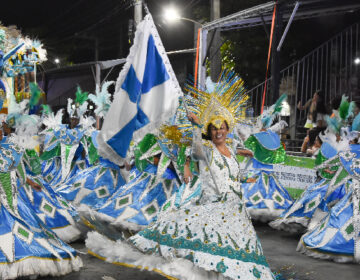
top-left (297, 145), bottom-right (360, 263)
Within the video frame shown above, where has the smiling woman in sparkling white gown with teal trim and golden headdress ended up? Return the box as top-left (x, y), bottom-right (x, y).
top-left (86, 72), bottom-right (275, 280)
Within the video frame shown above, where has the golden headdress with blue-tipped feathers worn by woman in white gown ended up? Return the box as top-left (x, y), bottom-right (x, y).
top-left (185, 71), bottom-right (249, 134)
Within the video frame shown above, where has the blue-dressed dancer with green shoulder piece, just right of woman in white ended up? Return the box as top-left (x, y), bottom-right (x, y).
top-left (236, 95), bottom-right (292, 222)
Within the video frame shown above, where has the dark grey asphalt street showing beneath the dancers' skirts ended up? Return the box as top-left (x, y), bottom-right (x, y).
top-left (47, 224), bottom-right (360, 280)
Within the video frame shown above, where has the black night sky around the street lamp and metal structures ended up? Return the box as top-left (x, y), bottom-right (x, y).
top-left (0, 0), bottom-right (359, 86)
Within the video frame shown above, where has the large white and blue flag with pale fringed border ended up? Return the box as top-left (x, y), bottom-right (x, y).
top-left (97, 14), bottom-right (181, 164)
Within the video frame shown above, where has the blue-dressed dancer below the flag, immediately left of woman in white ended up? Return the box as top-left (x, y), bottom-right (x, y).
top-left (85, 134), bottom-right (181, 231)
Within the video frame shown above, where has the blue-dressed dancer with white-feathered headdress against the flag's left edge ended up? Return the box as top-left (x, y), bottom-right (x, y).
top-left (56, 82), bottom-right (129, 209)
